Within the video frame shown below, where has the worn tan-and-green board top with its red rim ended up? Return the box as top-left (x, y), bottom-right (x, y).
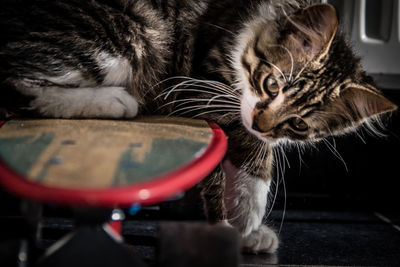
top-left (0, 117), bottom-right (226, 206)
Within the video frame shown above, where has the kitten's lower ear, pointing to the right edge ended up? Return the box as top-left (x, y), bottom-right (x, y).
top-left (328, 84), bottom-right (397, 124)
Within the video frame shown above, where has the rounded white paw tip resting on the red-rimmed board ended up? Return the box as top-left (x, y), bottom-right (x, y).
top-left (82, 87), bottom-right (139, 118)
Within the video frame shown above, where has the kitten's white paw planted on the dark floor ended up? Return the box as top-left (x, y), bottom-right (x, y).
top-left (242, 225), bottom-right (279, 254)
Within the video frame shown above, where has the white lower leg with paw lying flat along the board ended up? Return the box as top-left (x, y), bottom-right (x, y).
top-left (25, 87), bottom-right (139, 118)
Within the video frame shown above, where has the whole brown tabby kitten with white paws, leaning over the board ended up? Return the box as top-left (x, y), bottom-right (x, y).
top-left (0, 0), bottom-right (397, 253)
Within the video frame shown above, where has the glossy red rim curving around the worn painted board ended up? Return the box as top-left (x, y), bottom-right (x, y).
top-left (0, 121), bottom-right (228, 207)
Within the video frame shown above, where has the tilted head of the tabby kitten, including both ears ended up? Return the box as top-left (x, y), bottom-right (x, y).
top-left (236, 4), bottom-right (397, 146)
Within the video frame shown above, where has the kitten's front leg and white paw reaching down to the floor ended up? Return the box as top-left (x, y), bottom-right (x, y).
top-left (223, 160), bottom-right (279, 253)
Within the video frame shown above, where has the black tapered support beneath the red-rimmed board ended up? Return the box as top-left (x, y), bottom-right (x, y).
top-left (36, 208), bottom-right (147, 267)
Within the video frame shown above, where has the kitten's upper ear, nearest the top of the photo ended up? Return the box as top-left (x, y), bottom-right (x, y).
top-left (284, 4), bottom-right (338, 60)
